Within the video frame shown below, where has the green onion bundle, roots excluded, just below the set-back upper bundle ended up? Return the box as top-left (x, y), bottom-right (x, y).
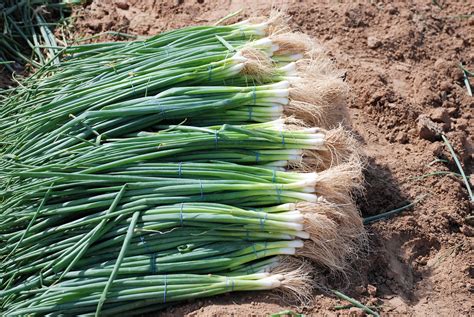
top-left (1, 82), bottom-right (288, 164)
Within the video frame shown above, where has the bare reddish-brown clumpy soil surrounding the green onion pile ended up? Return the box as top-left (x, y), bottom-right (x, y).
top-left (4, 0), bottom-right (474, 316)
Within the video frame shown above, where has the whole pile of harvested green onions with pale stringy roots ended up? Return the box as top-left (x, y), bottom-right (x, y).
top-left (0, 11), bottom-right (364, 315)
